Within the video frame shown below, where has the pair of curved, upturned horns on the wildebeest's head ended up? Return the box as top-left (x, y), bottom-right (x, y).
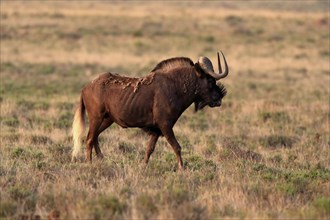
top-left (198, 51), bottom-right (229, 80)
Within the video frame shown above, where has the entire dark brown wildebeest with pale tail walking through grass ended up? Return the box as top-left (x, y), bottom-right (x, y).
top-left (72, 52), bottom-right (228, 168)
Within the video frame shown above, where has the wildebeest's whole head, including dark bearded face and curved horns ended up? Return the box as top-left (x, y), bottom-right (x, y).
top-left (195, 52), bottom-right (229, 111)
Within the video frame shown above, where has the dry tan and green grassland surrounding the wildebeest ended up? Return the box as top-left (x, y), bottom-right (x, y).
top-left (0, 1), bottom-right (330, 219)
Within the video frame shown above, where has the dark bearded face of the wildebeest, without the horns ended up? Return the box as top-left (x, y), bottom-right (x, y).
top-left (195, 76), bottom-right (227, 111)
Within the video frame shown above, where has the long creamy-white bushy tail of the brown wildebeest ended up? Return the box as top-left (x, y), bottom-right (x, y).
top-left (72, 97), bottom-right (85, 161)
